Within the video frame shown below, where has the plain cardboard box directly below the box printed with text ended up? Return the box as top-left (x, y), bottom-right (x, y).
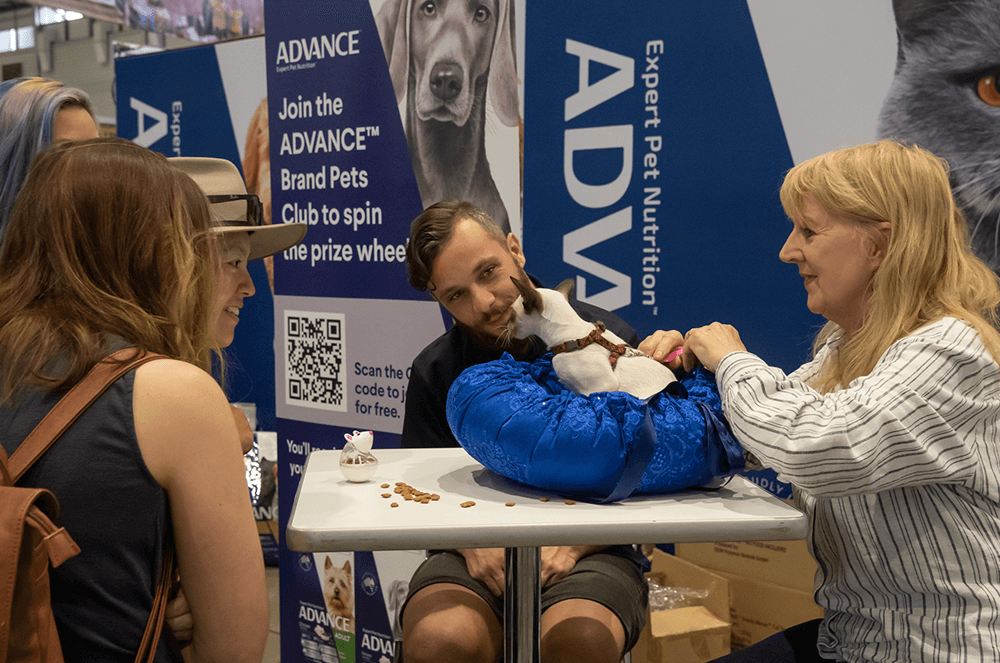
top-left (716, 571), bottom-right (823, 649)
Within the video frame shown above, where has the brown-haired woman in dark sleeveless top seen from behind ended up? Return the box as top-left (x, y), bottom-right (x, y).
top-left (0, 138), bottom-right (269, 661)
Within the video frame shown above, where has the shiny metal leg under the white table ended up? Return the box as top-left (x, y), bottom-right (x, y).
top-left (503, 547), bottom-right (541, 663)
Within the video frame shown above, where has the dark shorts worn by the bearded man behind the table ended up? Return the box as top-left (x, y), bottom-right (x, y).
top-left (403, 546), bottom-right (649, 651)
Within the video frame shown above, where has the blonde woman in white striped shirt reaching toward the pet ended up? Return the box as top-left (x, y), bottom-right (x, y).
top-left (684, 141), bottom-right (1000, 663)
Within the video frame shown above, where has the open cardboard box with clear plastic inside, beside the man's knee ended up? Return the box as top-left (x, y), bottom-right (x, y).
top-left (632, 550), bottom-right (730, 663)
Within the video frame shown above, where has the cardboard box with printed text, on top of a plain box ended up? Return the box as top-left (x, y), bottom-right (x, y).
top-left (674, 539), bottom-right (816, 592)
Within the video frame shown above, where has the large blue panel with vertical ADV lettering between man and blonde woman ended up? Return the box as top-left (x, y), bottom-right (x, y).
top-left (524, 0), bottom-right (820, 376)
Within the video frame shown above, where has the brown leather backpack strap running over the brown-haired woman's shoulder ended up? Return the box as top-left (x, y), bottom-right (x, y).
top-left (7, 348), bottom-right (167, 485)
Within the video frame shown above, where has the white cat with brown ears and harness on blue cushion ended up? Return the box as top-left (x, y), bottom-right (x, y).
top-left (505, 278), bottom-right (677, 398)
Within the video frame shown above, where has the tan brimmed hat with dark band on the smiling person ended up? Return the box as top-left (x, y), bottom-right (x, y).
top-left (169, 157), bottom-right (306, 260)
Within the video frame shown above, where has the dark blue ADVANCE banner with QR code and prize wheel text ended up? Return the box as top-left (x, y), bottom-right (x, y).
top-left (265, 0), bottom-right (520, 663)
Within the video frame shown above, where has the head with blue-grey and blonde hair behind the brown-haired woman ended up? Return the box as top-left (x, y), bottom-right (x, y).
top-left (0, 77), bottom-right (97, 245)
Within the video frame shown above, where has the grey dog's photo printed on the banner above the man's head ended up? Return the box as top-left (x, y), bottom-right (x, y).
top-left (373, 0), bottom-right (519, 232)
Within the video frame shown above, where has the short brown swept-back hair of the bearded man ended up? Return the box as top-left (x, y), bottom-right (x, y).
top-left (406, 200), bottom-right (507, 292)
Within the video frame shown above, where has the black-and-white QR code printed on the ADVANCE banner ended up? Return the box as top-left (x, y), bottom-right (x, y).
top-left (285, 311), bottom-right (347, 412)
